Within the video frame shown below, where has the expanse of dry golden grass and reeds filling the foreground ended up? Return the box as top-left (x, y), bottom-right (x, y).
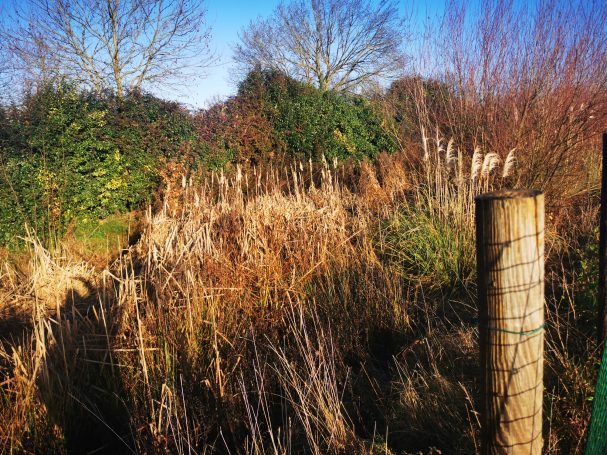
top-left (0, 144), bottom-right (596, 454)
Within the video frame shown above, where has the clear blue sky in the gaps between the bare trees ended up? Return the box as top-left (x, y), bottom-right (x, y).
top-left (176, 0), bottom-right (444, 109)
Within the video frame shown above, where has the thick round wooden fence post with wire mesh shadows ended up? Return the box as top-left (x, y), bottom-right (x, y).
top-left (476, 190), bottom-right (544, 455)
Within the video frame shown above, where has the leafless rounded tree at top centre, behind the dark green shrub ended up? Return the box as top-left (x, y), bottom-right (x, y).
top-left (234, 0), bottom-right (405, 91)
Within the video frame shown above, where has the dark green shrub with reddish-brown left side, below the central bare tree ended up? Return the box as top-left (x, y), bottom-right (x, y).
top-left (197, 70), bottom-right (396, 164)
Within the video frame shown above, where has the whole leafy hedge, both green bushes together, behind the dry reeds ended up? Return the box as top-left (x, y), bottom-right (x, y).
top-left (0, 70), bottom-right (396, 245)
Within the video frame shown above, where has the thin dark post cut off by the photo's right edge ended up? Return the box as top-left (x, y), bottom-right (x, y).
top-left (597, 133), bottom-right (607, 343)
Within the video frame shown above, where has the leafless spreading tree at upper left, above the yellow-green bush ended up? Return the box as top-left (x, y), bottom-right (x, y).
top-left (0, 0), bottom-right (211, 97)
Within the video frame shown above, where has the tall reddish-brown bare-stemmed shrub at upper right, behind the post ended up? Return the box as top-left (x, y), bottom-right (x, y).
top-left (410, 0), bottom-right (607, 194)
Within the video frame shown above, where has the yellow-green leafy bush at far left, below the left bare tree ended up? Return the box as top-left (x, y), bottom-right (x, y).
top-left (0, 85), bottom-right (195, 244)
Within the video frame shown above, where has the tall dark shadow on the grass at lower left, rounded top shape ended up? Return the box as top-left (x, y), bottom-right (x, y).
top-left (37, 279), bottom-right (135, 453)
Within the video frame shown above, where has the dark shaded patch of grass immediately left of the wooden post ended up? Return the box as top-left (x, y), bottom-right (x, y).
top-left (304, 269), bottom-right (480, 454)
